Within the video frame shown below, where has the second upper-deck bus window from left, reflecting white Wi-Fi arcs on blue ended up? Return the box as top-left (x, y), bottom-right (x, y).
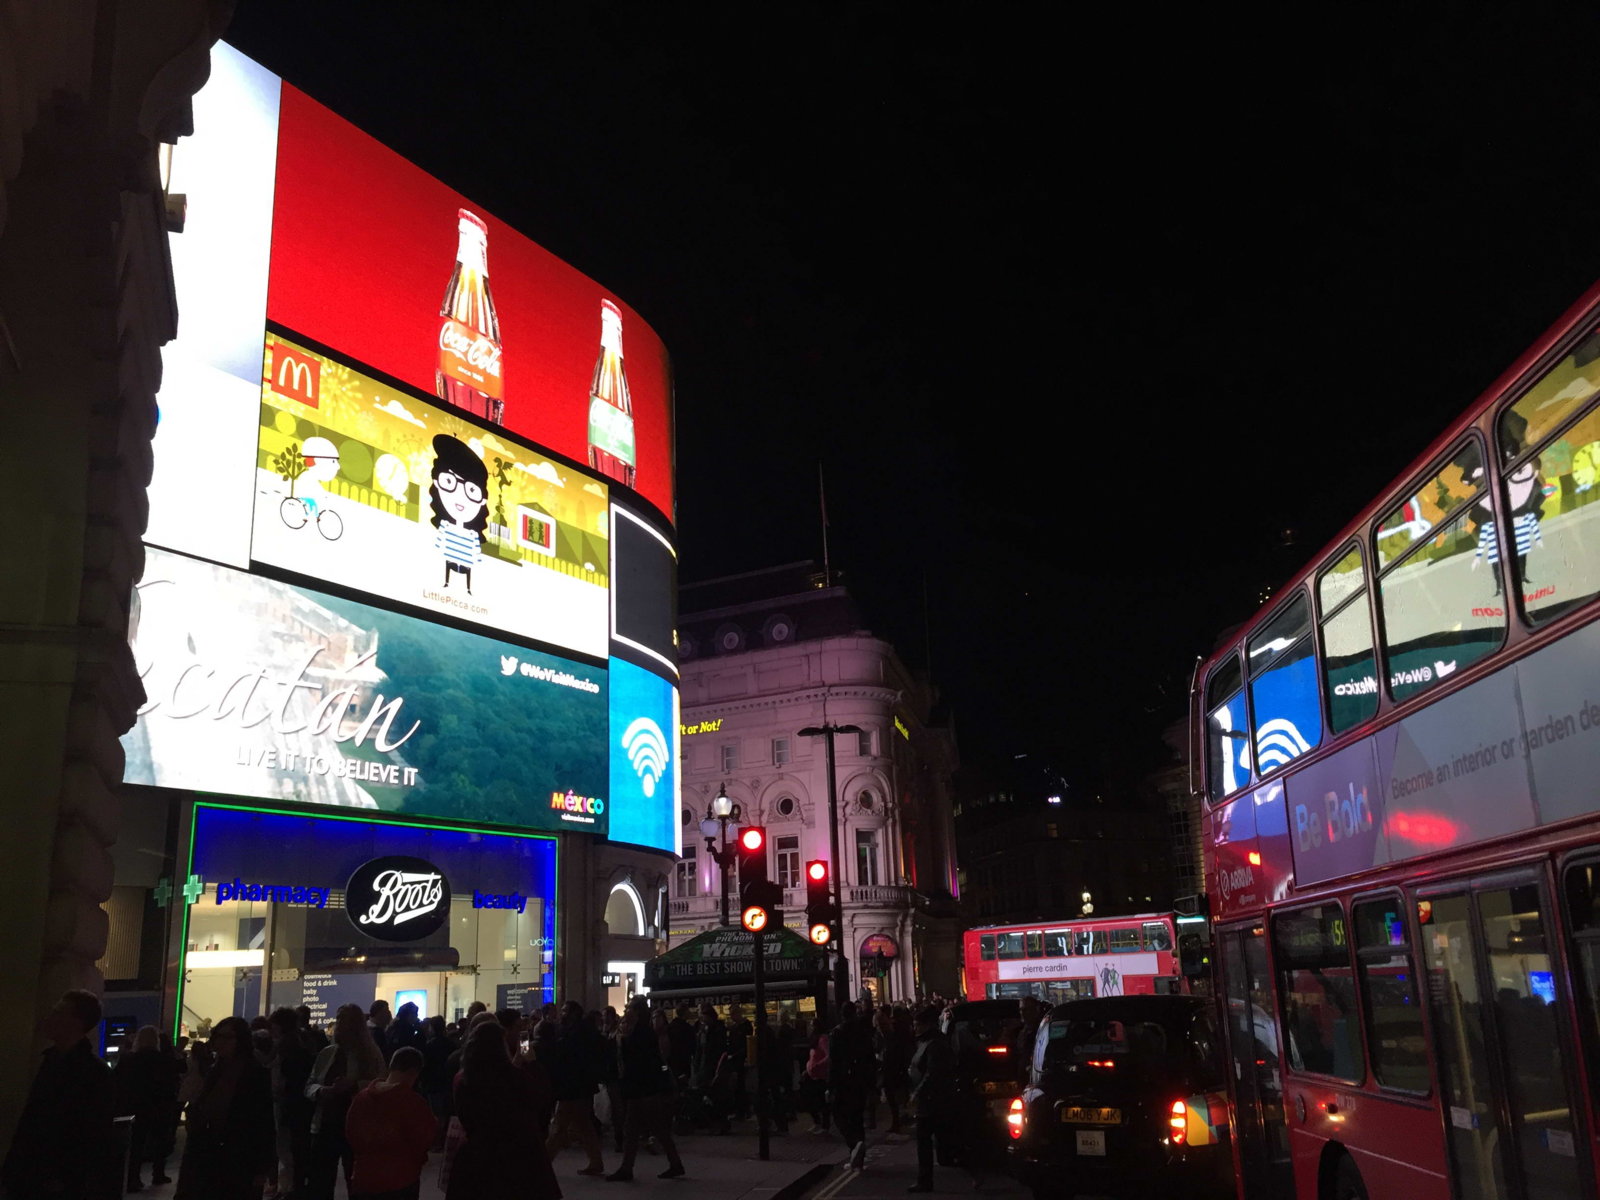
top-left (1248, 592), bottom-right (1322, 774)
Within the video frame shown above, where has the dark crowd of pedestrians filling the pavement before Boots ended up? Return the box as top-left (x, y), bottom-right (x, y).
top-left (0, 992), bottom-right (958, 1200)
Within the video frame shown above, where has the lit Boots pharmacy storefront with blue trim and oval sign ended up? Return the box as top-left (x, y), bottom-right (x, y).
top-left (176, 803), bottom-right (557, 1032)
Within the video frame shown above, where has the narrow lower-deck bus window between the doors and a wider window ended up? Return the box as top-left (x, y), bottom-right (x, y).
top-left (1352, 896), bottom-right (1429, 1094)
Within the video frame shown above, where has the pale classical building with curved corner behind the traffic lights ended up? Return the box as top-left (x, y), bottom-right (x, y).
top-left (669, 563), bottom-right (960, 1000)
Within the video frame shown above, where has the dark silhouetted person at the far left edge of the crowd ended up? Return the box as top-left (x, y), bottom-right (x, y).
top-left (0, 989), bottom-right (115, 1200)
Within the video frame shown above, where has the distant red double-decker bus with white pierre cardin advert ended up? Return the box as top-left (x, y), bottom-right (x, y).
top-left (962, 912), bottom-right (1186, 1005)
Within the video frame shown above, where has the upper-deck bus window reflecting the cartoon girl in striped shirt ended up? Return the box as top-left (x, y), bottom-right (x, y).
top-left (1488, 395), bottom-right (1600, 622)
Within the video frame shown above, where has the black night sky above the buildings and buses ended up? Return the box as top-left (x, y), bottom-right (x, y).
top-left (229, 0), bottom-right (1600, 790)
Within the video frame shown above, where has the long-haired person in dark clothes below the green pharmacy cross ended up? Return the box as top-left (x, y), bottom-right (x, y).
top-left (176, 1016), bottom-right (277, 1200)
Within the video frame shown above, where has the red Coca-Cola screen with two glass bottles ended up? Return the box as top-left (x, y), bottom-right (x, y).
top-left (267, 85), bottom-right (674, 518)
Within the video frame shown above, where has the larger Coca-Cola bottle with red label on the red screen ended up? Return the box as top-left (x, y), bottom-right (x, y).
top-left (434, 208), bottom-right (506, 424)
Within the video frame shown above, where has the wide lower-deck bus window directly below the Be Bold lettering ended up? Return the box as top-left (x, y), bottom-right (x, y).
top-left (1272, 902), bottom-right (1366, 1083)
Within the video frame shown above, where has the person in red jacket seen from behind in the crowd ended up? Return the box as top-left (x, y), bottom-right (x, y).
top-left (344, 1049), bottom-right (434, 1200)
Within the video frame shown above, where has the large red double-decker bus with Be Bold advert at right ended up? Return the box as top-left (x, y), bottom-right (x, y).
top-left (1190, 275), bottom-right (1600, 1200)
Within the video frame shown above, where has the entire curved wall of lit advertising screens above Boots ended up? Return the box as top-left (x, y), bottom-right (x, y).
top-left (125, 45), bottom-right (677, 848)
